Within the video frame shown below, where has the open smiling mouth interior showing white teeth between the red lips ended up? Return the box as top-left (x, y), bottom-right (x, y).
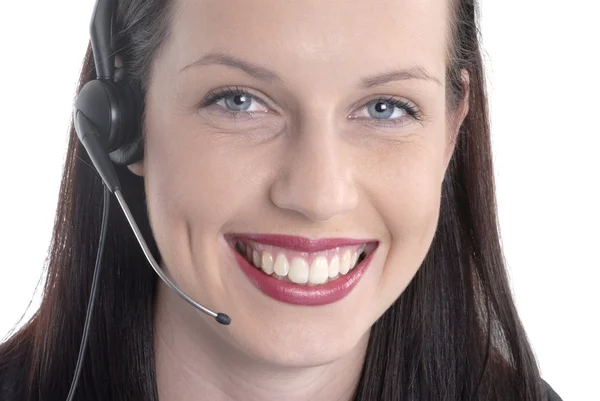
top-left (231, 237), bottom-right (377, 286)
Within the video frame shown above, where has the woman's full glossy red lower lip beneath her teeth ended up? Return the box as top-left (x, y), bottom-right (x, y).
top-left (228, 241), bottom-right (377, 306)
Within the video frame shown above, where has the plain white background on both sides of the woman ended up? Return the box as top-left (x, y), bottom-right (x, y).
top-left (0, 0), bottom-right (600, 401)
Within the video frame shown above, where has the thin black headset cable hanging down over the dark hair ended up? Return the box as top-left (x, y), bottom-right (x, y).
top-left (67, 184), bottom-right (110, 401)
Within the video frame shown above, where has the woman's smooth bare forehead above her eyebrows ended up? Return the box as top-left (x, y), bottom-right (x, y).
top-left (165, 0), bottom-right (448, 86)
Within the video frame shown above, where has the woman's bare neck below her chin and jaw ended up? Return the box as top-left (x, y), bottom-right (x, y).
top-left (154, 284), bottom-right (368, 401)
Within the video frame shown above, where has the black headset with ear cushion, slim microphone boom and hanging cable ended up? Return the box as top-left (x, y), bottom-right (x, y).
top-left (67, 0), bottom-right (231, 401)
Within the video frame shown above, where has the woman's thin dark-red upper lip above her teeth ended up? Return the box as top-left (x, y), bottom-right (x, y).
top-left (226, 234), bottom-right (377, 252)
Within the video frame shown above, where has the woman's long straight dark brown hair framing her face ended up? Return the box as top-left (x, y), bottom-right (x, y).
top-left (0, 0), bottom-right (545, 401)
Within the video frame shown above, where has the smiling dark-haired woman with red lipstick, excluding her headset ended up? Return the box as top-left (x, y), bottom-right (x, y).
top-left (0, 0), bottom-right (560, 401)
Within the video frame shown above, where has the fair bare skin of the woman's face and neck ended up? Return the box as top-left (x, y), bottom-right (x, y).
top-left (130, 0), bottom-right (468, 401)
